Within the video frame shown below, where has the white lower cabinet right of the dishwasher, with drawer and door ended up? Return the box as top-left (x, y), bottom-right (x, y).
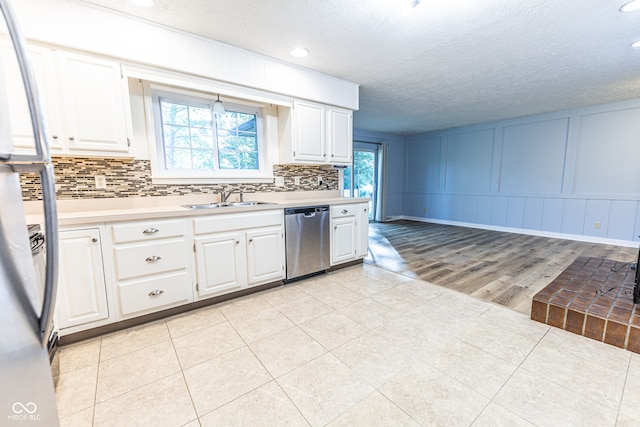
top-left (331, 203), bottom-right (369, 265)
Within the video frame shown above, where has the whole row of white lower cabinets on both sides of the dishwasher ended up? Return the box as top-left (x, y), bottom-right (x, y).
top-left (54, 203), bottom-right (368, 336)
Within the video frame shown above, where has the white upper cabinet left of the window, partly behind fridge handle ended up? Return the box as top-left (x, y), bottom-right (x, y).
top-left (0, 38), bottom-right (130, 156)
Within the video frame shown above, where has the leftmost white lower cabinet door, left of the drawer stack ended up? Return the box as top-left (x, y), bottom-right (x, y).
top-left (55, 229), bottom-right (109, 329)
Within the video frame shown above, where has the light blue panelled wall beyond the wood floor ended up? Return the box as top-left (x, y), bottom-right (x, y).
top-left (402, 99), bottom-right (640, 244)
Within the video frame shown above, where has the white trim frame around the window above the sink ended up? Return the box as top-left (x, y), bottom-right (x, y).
top-left (143, 82), bottom-right (277, 184)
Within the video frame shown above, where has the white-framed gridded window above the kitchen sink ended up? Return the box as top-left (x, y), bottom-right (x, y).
top-left (151, 87), bottom-right (267, 182)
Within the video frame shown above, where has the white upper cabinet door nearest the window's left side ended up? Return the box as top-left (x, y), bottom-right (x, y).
top-left (59, 52), bottom-right (128, 152)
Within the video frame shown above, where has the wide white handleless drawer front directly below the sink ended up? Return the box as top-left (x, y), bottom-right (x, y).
top-left (193, 209), bottom-right (284, 234)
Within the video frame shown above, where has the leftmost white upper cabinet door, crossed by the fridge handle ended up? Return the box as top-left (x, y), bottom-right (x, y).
top-left (0, 39), bottom-right (60, 153)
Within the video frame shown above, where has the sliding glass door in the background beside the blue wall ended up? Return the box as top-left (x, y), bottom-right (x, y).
top-left (344, 142), bottom-right (379, 220)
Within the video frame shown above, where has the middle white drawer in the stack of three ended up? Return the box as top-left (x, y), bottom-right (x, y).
top-left (114, 239), bottom-right (188, 280)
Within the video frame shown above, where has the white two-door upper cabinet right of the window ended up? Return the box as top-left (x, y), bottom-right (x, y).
top-left (278, 100), bottom-right (353, 165)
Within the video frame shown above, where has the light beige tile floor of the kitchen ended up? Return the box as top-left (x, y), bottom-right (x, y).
top-left (57, 264), bottom-right (640, 427)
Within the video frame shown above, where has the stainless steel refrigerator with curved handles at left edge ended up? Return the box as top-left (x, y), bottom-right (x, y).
top-left (0, 0), bottom-right (58, 427)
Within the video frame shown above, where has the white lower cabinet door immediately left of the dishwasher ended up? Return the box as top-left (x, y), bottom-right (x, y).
top-left (247, 227), bottom-right (284, 285)
